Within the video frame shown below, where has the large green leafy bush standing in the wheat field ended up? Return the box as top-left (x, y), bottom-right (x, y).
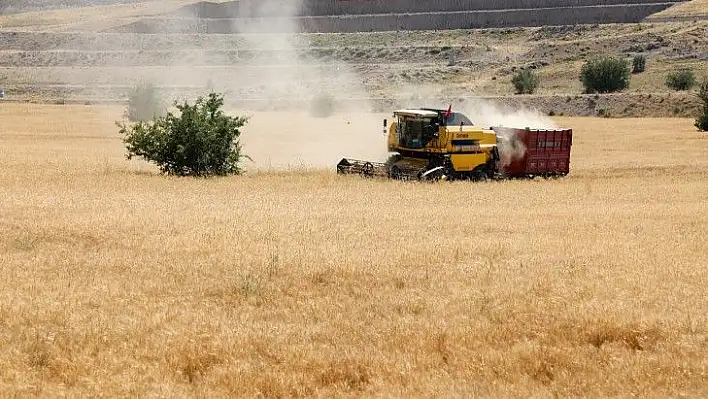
top-left (118, 93), bottom-right (247, 176)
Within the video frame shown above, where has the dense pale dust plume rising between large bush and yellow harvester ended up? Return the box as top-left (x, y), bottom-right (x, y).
top-left (205, 0), bottom-right (387, 170)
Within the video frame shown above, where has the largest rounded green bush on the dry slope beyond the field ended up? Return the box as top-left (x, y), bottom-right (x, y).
top-left (580, 57), bottom-right (629, 93)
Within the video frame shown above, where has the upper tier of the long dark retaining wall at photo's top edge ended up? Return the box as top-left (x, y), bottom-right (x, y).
top-left (178, 0), bottom-right (684, 19)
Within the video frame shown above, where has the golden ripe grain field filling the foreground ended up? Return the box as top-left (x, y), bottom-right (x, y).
top-left (0, 104), bottom-right (708, 397)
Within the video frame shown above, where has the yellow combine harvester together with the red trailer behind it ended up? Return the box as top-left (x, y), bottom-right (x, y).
top-left (337, 107), bottom-right (573, 181)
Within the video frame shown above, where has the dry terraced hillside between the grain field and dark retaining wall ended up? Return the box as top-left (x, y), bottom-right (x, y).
top-left (0, 22), bottom-right (708, 116)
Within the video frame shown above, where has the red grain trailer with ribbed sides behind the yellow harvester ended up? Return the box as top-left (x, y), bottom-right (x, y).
top-left (493, 127), bottom-right (573, 178)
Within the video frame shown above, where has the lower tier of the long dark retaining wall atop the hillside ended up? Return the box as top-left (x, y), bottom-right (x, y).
top-left (112, 4), bottom-right (667, 34)
